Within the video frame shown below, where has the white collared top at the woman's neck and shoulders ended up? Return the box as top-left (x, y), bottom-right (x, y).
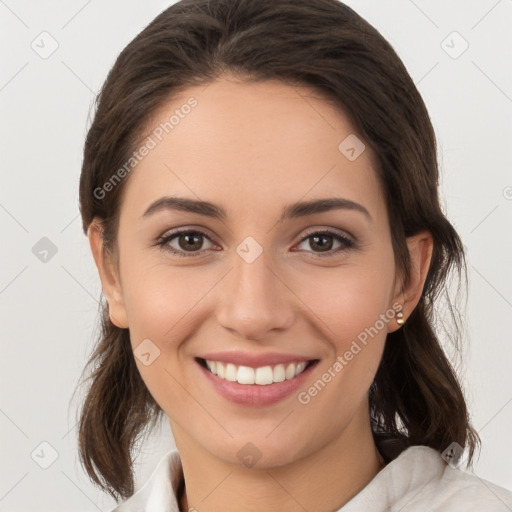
top-left (109, 446), bottom-right (512, 512)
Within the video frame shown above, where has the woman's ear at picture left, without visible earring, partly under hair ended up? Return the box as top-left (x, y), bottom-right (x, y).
top-left (87, 218), bottom-right (128, 329)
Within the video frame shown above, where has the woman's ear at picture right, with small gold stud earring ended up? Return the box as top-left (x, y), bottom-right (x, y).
top-left (388, 231), bottom-right (434, 332)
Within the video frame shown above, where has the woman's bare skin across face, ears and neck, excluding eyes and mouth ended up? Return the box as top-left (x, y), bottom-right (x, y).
top-left (89, 76), bottom-right (432, 512)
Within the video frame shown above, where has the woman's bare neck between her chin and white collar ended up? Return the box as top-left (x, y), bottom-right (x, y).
top-left (173, 411), bottom-right (384, 512)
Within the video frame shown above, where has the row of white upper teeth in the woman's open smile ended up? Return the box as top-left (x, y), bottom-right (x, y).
top-left (206, 360), bottom-right (307, 386)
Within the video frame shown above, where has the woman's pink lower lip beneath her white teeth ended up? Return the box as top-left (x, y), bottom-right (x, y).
top-left (197, 361), bottom-right (318, 407)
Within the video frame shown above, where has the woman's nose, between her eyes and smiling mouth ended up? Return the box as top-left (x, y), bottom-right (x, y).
top-left (216, 251), bottom-right (294, 340)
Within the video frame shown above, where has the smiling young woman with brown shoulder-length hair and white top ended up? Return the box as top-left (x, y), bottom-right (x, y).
top-left (75, 0), bottom-right (512, 512)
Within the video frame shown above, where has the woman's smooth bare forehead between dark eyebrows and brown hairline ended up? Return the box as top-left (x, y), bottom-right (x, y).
top-left (121, 79), bottom-right (383, 224)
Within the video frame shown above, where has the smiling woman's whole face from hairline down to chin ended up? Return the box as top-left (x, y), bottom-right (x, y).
top-left (94, 78), bottom-right (410, 467)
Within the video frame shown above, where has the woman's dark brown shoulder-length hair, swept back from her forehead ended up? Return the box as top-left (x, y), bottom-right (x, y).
top-left (78, 0), bottom-right (480, 499)
